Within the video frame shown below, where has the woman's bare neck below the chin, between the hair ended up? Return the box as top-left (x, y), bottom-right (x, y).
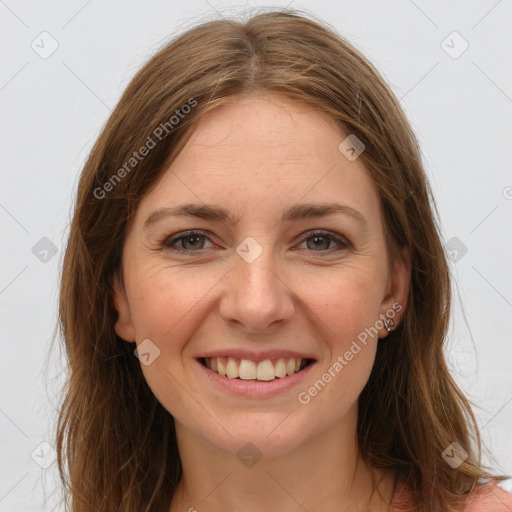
top-left (170, 408), bottom-right (393, 512)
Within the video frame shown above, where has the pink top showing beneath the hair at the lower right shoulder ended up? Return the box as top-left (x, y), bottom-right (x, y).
top-left (391, 480), bottom-right (512, 512)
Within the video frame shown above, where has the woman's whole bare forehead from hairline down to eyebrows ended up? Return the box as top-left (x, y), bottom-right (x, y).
top-left (134, 94), bottom-right (379, 228)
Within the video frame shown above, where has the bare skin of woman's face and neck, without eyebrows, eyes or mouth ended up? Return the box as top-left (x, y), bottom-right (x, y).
top-left (114, 94), bottom-right (410, 512)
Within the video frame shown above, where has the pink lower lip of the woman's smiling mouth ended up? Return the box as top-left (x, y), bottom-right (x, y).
top-left (196, 359), bottom-right (316, 398)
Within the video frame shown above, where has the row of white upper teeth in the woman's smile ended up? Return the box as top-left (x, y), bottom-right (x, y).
top-left (204, 357), bottom-right (307, 381)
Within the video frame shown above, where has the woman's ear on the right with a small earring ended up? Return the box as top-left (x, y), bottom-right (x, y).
top-left (380, 247), bottom-right (411, 338)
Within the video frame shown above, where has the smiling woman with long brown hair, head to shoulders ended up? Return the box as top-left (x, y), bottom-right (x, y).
top-left (57, 11), bottom-right (512, 512)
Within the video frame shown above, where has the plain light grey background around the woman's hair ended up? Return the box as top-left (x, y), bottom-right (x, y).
top-left (0, 0), bottom-right (512, 512)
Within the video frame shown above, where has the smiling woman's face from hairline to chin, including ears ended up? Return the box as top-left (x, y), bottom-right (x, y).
top-left (114, 95), bottom-right (408, 456)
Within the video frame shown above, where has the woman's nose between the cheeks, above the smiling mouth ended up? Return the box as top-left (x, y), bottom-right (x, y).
top-left (220, 249), bottom-right (295, 333)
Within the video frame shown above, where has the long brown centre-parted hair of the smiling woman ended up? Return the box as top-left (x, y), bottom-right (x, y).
top-left (56, 10), bottom-right (508, 512)
